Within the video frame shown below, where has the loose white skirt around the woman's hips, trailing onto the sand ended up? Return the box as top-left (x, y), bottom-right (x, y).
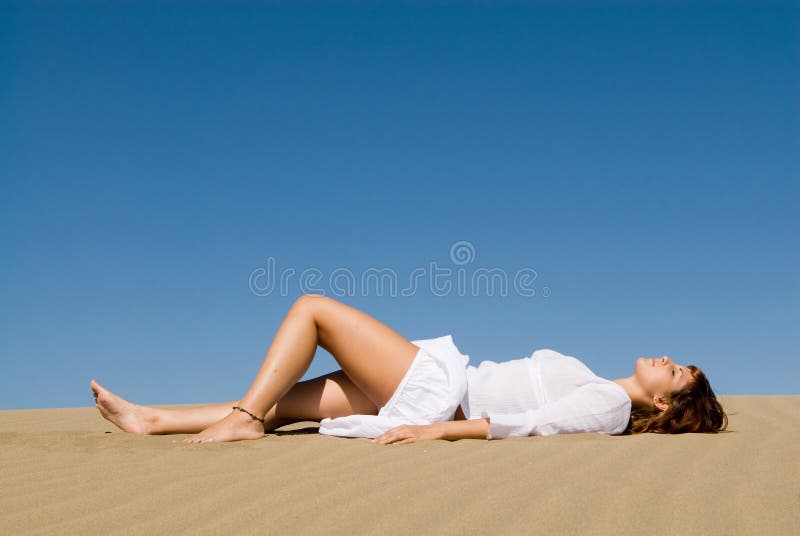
top-left (319, 335), bottom-right (469, 438)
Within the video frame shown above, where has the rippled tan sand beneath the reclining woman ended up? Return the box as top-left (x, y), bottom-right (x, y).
top-left (0, 396), bottom-right (800, 535)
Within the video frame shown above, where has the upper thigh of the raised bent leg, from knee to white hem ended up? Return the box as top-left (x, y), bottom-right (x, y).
top-left (302, 295), bottom-right (419, 408)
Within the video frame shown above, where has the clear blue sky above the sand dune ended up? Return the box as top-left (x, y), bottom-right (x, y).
top-left (0, 2), bottom-right (800, 409)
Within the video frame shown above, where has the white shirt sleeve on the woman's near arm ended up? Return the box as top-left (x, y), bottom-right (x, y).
top-left (481, 383), bottom-right (631, 439)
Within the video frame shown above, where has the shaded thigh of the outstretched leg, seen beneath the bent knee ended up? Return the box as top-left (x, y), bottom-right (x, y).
top-left (275, 370), bottom-right (379, 422)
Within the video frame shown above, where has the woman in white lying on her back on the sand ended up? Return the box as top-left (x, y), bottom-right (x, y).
top-left (90, 295), bottom-right (727, 444)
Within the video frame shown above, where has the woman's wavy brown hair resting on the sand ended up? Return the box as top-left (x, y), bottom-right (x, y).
top-left (623, 365), bottom-right (728, 435)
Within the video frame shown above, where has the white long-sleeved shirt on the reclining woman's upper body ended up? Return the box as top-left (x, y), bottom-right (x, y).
top-left (461, 349), bottom-right (631, 439)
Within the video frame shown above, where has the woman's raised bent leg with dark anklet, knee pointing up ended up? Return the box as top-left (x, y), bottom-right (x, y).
top-left (184, 295), bottom-right (419, 443)
